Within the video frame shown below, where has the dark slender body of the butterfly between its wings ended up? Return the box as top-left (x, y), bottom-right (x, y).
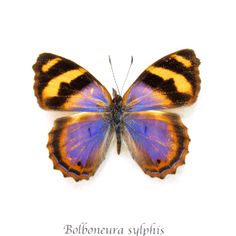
top-left (111, 89), bottom-right (123, 154)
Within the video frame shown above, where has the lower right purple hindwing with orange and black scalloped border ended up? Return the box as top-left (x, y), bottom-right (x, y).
top-left (123, 111), bottom-right (189, 178)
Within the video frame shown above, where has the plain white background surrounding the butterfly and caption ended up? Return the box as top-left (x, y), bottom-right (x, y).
top-left (0, 0), bottom-right (236, 236)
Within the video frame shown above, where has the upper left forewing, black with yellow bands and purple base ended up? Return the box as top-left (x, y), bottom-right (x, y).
top-left (33, 53), bottom-right (111, 112)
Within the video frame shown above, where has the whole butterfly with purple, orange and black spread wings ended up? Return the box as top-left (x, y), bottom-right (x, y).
top-left (33, 49), bottom-right (200, 181)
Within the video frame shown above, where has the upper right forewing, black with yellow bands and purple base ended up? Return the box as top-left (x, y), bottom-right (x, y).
top-left (123, 49), bottom-right (200, 111)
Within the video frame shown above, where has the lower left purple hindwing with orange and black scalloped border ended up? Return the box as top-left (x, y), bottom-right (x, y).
top-left (48, 112), bottom-right (114, 181)
